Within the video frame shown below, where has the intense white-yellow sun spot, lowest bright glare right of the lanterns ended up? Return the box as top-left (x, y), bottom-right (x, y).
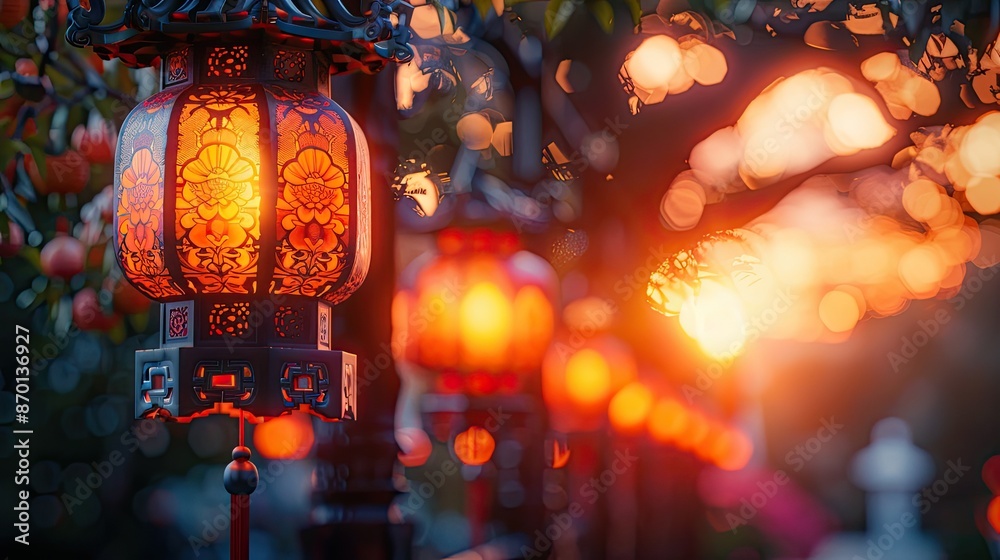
top-left (680, 280), bottom-right (746, 357)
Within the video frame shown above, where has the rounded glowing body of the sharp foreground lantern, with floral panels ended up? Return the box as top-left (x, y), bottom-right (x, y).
top-left (116, 49), bottom-right (371, 304)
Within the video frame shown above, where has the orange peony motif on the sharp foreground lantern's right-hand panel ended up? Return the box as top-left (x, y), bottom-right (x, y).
top-left (278, 148), bottom-right (346, 251)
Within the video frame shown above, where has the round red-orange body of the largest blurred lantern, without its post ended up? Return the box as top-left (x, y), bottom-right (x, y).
top-left (393, 230), bottom-right (558, 394)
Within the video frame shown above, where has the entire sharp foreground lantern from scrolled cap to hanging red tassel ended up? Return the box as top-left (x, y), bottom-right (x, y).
top-left (67, 0), bottom-right (412, 558)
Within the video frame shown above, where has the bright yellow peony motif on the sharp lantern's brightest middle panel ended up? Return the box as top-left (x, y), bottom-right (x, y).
top-left (178, 144), bottom-right (260, 247)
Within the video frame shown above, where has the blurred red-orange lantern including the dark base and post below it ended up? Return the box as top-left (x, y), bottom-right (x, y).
top-left (392, 230), bottom-right (562, 546)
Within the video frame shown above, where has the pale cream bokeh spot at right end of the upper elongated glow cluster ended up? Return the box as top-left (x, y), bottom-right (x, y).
top-left (827, 93), bottom-right (896, 155)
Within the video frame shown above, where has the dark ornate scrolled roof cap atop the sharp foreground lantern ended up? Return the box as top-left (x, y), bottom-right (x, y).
top-left (66, 0), bottom-right (413, 72)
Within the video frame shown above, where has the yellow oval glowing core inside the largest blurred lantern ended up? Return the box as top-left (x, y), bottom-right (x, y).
top-left (459, 282), bottom-right (513, 367)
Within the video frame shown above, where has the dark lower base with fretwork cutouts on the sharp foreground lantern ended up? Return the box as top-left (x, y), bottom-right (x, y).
top-left (135, 347), bottom-right (357, 422)
